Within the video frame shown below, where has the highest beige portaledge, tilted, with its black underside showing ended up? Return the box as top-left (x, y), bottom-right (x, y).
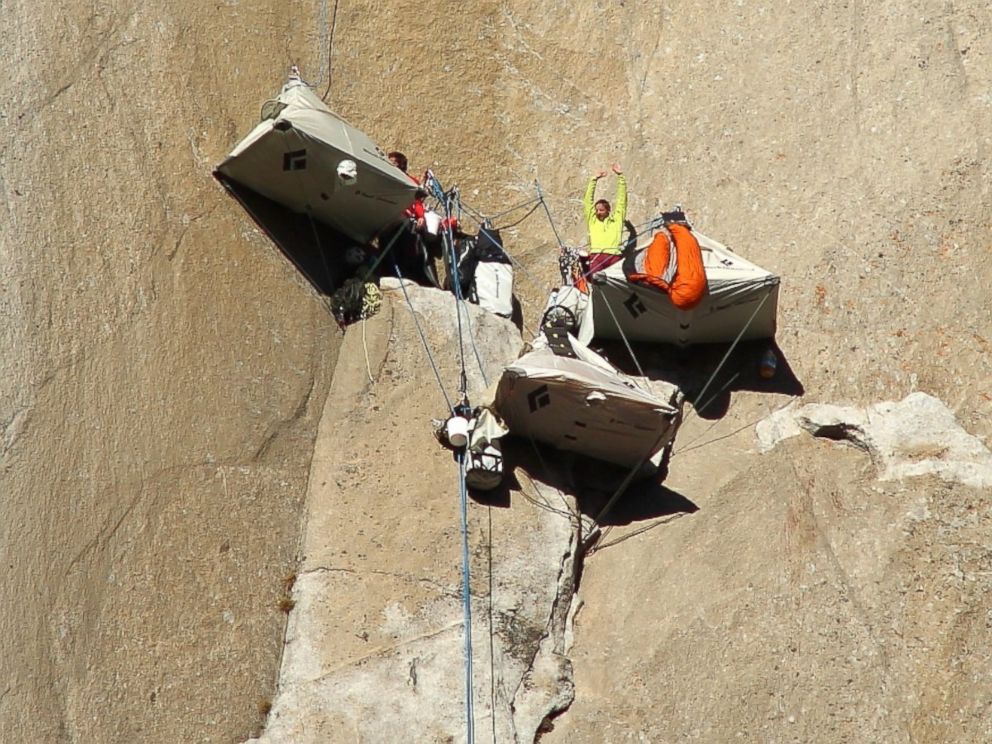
top-left (214, 69), bottom-right (417, 295)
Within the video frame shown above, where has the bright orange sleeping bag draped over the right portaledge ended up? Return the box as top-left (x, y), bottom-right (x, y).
top-left (627, 223), bottom-right (706, 310)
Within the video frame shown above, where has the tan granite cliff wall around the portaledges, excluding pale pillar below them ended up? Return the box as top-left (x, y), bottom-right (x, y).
top-left (0, 0), bottom-right (992, 742)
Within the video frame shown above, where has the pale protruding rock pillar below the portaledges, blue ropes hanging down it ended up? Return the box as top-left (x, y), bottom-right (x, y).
top-left (253, 280), bottom-right (579, 744)
